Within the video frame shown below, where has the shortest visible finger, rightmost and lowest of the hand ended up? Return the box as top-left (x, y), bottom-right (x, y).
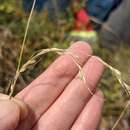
top-left (71, 91), bottom-right (104, 130)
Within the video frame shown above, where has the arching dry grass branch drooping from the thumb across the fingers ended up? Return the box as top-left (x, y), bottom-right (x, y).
top-left (9, 48), bottom-right (93, 97)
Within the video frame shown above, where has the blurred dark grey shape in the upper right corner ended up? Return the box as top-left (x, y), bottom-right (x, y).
top-left (100, 0), bottom-right (130, 49)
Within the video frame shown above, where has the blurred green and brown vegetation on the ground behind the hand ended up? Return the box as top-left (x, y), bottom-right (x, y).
top-left (0, 0), bottom-right (130, 130)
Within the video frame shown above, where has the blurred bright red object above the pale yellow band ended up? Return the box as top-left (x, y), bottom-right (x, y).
top-left (74, 9), bottom-right (93, 31)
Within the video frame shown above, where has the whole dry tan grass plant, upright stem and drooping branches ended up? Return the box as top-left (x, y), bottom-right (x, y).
top-left (9, 0), bottom-right (130, 130)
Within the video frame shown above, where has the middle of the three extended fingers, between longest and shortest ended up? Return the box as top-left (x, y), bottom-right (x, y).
top-left (34, 56), bottom-right (104, 130)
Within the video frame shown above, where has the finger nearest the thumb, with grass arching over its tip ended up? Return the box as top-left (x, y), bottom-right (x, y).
top-left (17, 42), bottom-right (92, 129)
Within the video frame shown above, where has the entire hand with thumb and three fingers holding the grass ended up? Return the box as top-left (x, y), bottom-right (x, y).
top-left (0, 42), bottom-right (105, 130)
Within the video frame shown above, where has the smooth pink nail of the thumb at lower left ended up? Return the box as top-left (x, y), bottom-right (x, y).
top-left (0, 101), bottom-right (20, 130)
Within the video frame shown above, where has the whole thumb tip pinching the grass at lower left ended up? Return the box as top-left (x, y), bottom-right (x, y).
top-left (0, 94), bottom-right (27, 130)
